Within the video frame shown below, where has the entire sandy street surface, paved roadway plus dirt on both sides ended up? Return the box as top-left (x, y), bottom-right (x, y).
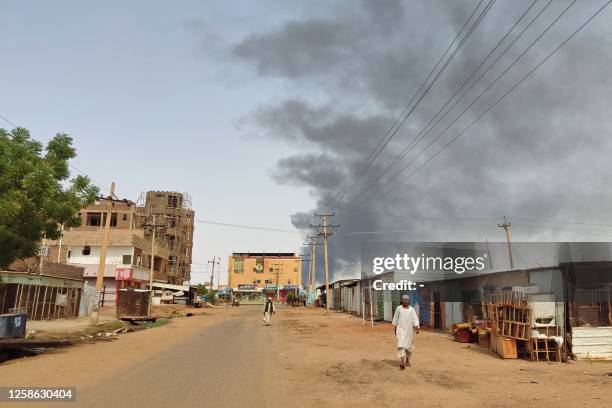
top-left (0, 306), bottom-right (612, 408)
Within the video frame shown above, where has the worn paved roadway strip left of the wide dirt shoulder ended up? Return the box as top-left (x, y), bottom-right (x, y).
top-left (77, 306), bottom-right (278, 408)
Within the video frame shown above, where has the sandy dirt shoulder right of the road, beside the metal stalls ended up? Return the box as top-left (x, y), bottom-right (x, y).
top-left (276, 308), bottom-right (612, 408)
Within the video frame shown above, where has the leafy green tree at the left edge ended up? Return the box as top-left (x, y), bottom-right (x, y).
top-left (0, 128), bottom-right (99, 268)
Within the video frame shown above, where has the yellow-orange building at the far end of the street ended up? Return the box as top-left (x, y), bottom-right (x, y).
top-left (227, 252), bottom-right (302, 300)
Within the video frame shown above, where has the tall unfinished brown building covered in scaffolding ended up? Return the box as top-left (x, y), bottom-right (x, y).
top-left (138, 191), bottom-right (194, 284)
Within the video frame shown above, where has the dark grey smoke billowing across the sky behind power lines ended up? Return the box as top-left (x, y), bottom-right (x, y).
top-left (229, 0), bottom-right (612, 278)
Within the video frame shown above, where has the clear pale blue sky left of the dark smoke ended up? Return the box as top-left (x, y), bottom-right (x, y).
top-left (0, 1), bottom-right (312, 281)
